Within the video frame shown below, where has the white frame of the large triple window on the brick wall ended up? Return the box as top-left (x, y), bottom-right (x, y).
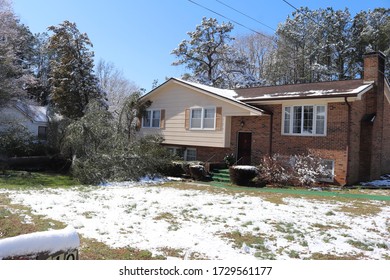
top-left (281, 104), bottom-right (328, 136)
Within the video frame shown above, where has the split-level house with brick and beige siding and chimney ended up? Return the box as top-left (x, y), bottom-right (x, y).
top-left (140, 52), bottom-right (390, 185)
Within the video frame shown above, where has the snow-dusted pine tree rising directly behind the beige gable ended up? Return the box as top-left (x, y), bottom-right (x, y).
top-left (172, 18), bottom-right (254, 88)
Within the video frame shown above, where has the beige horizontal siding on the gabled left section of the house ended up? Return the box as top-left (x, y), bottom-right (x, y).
top-left (141, 83), bottom-right (258, 147)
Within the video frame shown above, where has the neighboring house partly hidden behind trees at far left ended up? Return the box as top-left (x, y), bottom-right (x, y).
top-left (0, 101), bottom-right (49, 140)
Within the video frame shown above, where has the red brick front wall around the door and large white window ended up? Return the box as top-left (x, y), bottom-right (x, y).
top-left (227, 102), bottom-right (352, 185)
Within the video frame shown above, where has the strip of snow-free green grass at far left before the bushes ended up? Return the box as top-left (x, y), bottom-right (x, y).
top-left (0, 171), bottom-right (80, 189)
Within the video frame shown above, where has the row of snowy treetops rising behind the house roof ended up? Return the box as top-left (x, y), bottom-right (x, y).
top-left (172, 7), bottom-right (390, 88)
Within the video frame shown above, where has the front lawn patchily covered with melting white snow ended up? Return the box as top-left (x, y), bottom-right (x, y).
top-left (0, 182), bottom-right (390, 260)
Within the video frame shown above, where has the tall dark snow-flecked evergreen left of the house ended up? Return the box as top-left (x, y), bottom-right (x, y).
top-left (48, 21), bottom-right (104, 119)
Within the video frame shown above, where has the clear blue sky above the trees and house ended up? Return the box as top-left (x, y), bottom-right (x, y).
top-left (13, 0), bottom-right (390, 90)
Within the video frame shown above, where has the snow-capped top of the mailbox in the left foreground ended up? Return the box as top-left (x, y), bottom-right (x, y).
top-left (0, 226), bottom-right (80, 260)
